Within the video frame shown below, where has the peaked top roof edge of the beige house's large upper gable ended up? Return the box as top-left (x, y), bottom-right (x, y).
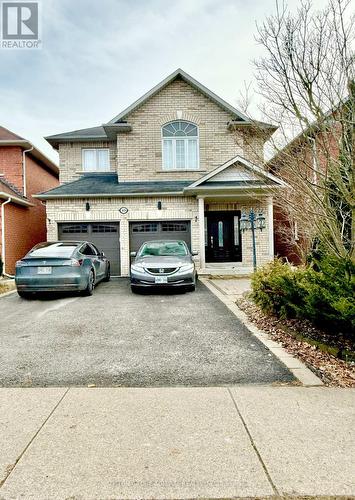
top-left (109, 68), bottom-right (250, 123)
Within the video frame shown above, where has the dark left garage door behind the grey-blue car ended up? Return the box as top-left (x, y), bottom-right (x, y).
top-left (58, 222), bottom-right (120, 276)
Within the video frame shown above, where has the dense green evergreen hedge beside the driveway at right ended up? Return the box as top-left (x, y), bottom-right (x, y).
top-left (252, 257), bottom-right (355, 335)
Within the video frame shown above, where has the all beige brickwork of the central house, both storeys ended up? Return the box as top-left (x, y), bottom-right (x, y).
top-left (46, 74), bottom-right (273, 276)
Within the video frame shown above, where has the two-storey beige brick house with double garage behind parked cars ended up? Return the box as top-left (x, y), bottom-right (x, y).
top-left (38, 70), bottom-right (283, 276)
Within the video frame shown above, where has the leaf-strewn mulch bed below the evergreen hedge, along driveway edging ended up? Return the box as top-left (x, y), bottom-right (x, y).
top-left (236, 297), bottom-right (355, 387)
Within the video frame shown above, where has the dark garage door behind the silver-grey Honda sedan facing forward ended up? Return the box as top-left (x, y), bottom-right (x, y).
top-left (130, 221), bottom-right (191, 252)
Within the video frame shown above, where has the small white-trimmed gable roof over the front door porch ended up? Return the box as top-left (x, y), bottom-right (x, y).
top-left (188, 155), bottom-right (287, 190)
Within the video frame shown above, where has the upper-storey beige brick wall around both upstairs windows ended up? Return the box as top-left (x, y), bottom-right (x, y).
top-left (59, 79), bottom-right (263, 183)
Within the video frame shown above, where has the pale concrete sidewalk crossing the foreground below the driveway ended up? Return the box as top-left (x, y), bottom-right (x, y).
top-left (0, 386), bottom-right (355, 500)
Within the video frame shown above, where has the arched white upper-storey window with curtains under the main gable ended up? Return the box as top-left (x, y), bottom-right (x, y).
top-left (162, 121), bottom-right (199, 170)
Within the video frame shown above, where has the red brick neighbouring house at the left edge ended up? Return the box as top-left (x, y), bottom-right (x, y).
top-left (0, 127), bottom-right (59, 275)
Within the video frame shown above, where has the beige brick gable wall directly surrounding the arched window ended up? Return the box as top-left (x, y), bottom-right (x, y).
top-left (117, 80), bottom-right (248, 181)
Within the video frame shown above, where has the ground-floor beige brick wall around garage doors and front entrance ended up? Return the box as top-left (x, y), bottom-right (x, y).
top-left (46, 196), bottom-right (272, 276)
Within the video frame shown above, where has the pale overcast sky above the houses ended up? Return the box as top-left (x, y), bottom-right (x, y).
top-left (0, 0), bottom-right (326, 163)
